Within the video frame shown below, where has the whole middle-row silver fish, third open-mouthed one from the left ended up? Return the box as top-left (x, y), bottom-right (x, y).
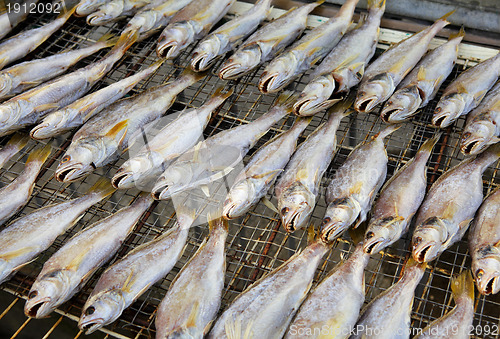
top-left (152, 92), bottom-right (296, 200)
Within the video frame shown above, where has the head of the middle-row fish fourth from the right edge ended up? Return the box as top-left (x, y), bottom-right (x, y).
top-left (320, 197), bottom-right (361, 243)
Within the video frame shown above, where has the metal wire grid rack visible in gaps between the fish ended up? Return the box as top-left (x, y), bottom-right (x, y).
top-left (0, 2), bottom-right (500, 338)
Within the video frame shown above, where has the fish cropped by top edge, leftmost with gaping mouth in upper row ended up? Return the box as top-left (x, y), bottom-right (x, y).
top-left (156, 0), bottom-right (236, 59)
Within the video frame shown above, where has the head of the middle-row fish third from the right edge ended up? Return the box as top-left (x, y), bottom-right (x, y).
top-left (363, 216), bottom-right (405, 254)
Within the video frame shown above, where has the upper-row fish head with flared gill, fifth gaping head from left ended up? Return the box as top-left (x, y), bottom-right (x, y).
top-left (293, 74), bottom-right (340, 116)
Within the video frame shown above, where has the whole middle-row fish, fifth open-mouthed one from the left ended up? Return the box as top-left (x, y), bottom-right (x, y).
top-left (274, 100), bottom-right (352, 232)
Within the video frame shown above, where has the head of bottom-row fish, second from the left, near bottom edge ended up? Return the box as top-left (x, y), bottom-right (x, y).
top-left (78, 290), bottom-right (125, 334)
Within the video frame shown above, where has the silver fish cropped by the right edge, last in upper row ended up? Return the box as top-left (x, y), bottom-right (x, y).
top-left (460, 82), bottom-right (500, 155)
